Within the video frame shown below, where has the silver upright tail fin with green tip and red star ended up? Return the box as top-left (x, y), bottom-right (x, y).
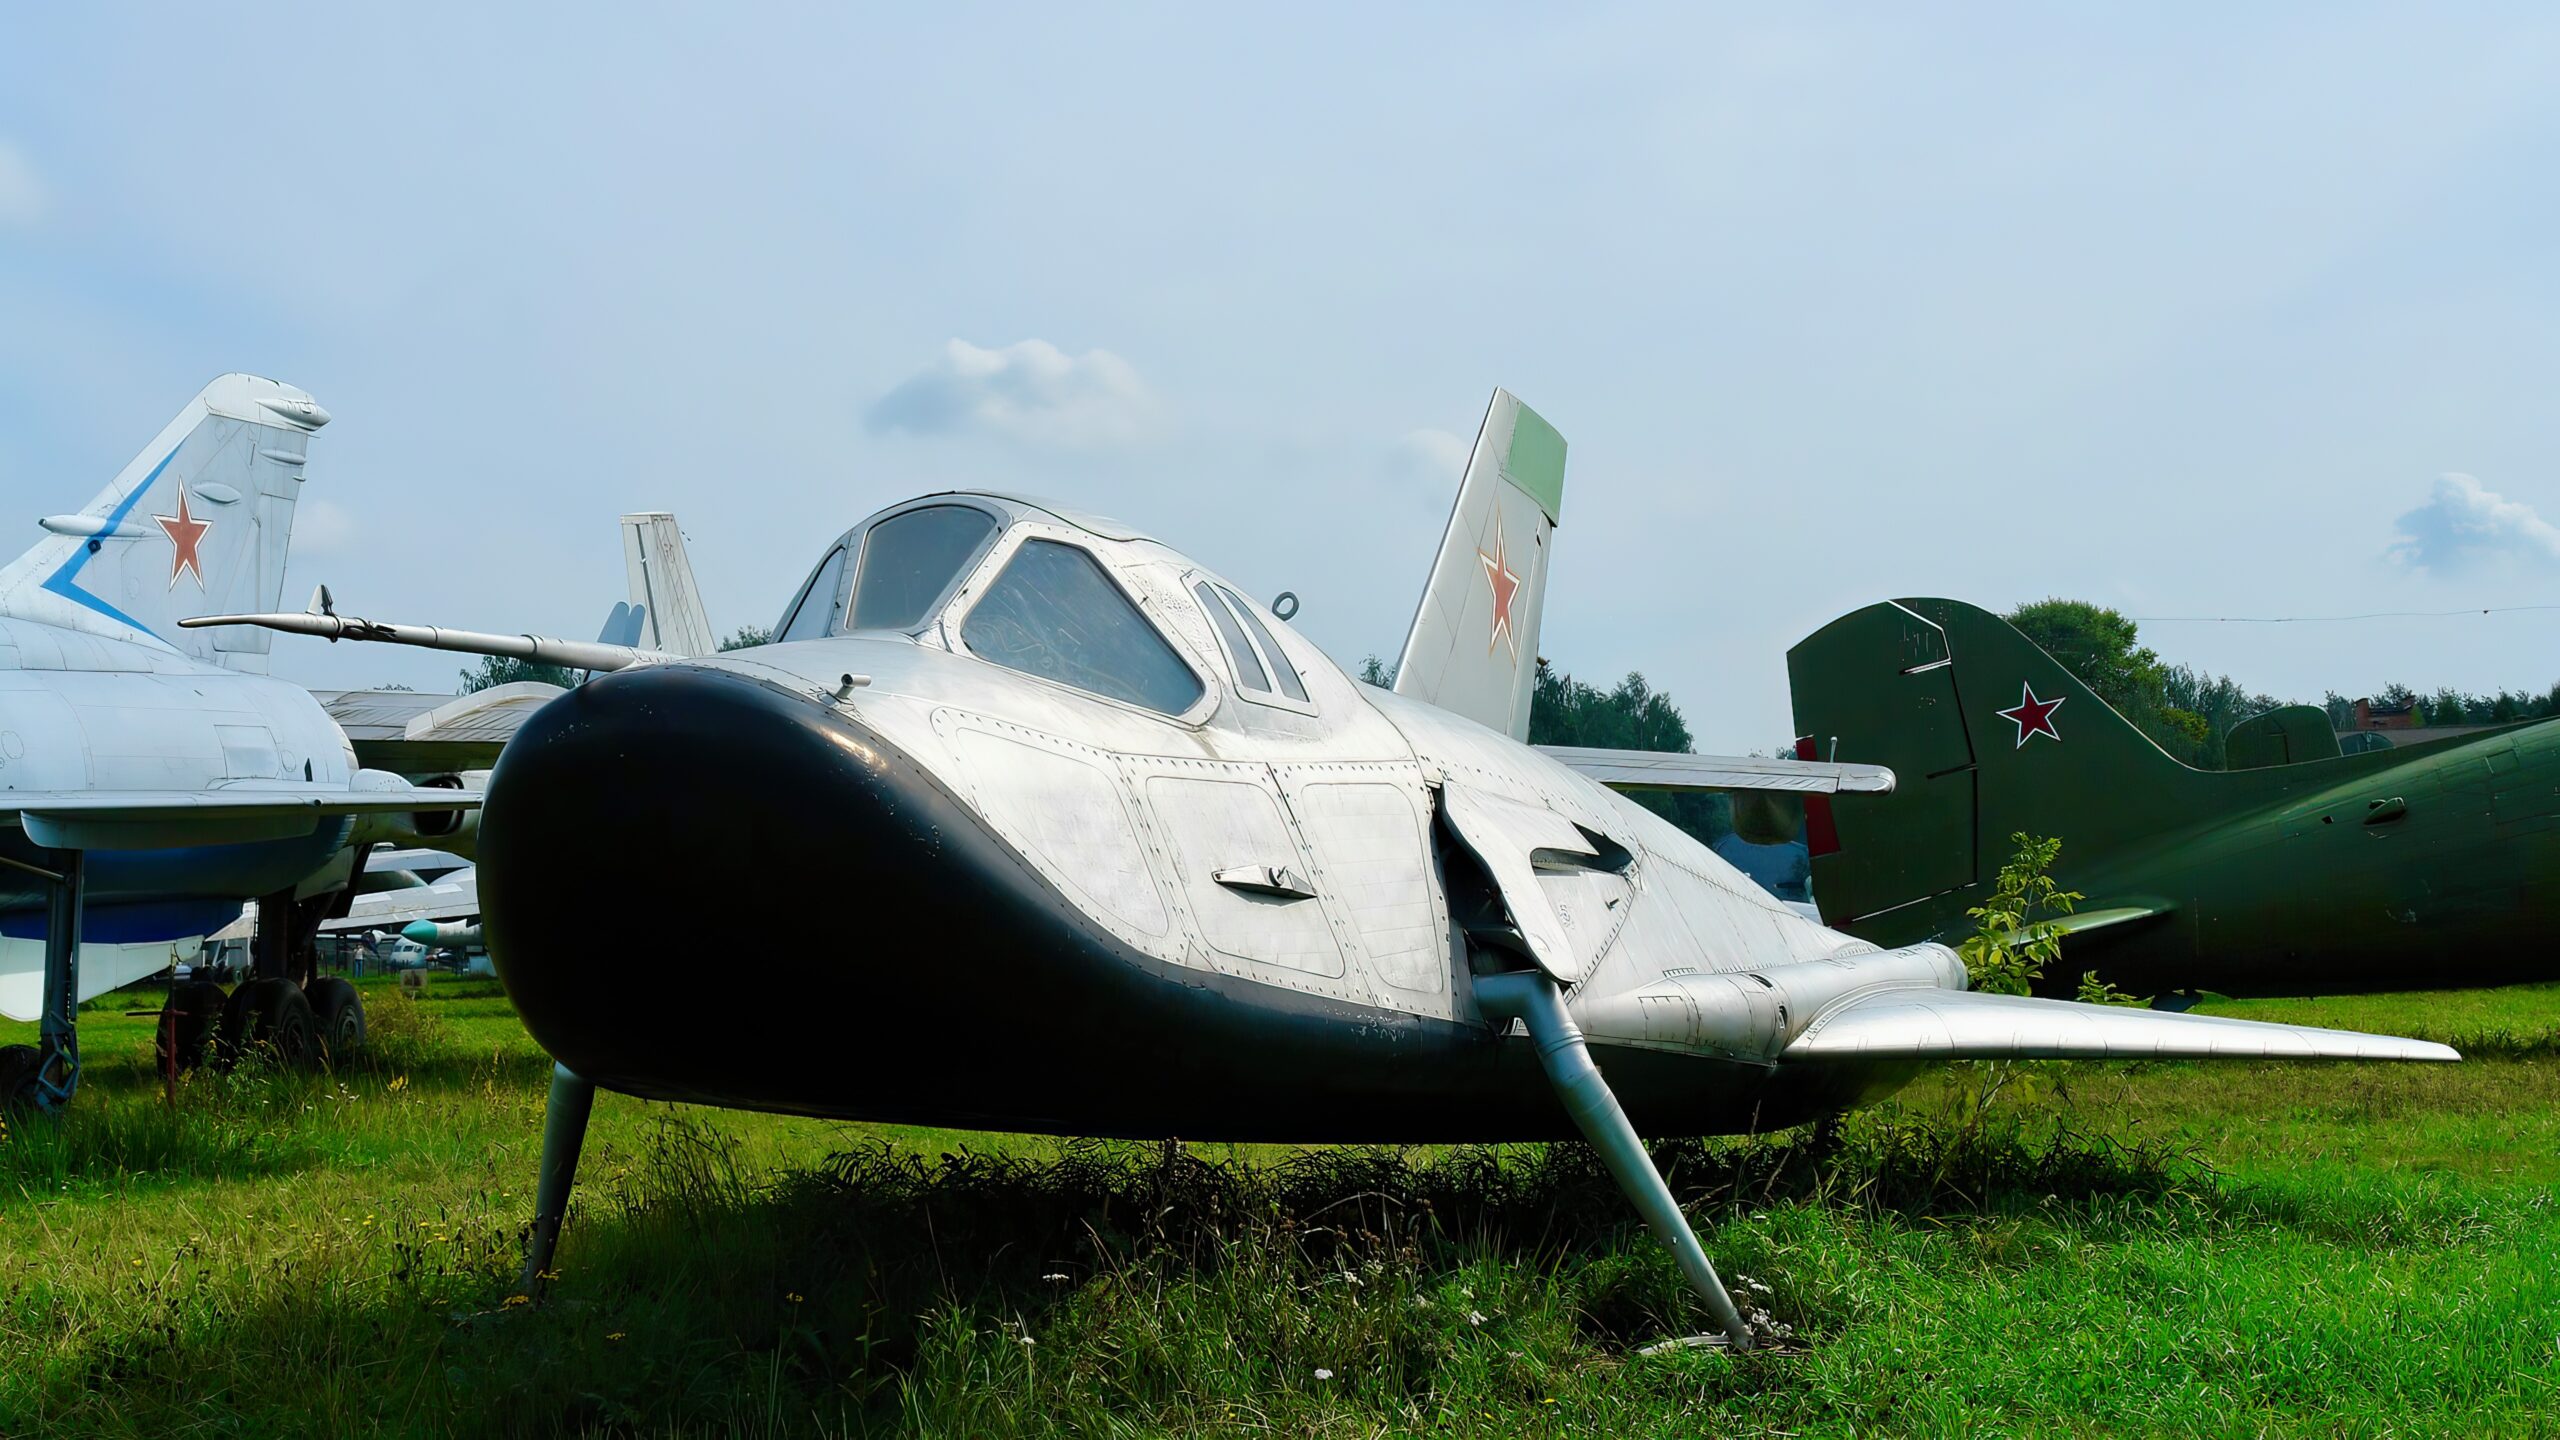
top-left (1395, 389), bottom-right (1564, 740)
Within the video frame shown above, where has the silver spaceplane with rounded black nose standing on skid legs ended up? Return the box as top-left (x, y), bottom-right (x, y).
top-left (189, 392), bottom-right (2455, 1345)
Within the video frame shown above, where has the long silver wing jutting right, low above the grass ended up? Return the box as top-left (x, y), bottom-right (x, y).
top-left (1782, 989), bottom-right (2463, 1061)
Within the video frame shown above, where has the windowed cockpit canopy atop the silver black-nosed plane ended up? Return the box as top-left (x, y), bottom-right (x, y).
top-left (773, 495), bottom-right (1311, 715)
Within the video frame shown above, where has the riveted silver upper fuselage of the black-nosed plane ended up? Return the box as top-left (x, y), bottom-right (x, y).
top-left (670, 515), bottom-right (1874, 1040)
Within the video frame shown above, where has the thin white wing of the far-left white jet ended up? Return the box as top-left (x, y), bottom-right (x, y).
top-left (0, 784), bottom-right (481, 851)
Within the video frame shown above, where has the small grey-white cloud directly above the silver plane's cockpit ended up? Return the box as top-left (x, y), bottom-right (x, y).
top-left (863, 341), bottom-right (1162, 448)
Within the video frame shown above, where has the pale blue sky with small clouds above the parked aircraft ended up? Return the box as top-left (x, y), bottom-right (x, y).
top-left (0, 5), bottom-right (2560, 748)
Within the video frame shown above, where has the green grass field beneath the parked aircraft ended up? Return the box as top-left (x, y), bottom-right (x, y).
top-left (0, 968), bottom-right (2560, 1437)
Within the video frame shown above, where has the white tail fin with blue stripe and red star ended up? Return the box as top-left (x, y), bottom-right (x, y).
top-left (0, 374), bottom-right (328, 674)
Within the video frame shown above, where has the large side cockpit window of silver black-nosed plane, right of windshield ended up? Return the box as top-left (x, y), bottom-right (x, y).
top-left (960, 541), bottom-right (1201, 715)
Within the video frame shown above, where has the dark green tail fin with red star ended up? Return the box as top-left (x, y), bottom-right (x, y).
top-left (1787, 600), bottom-right (2191, 933)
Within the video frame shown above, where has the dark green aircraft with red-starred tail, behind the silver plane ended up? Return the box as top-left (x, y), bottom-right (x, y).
top-left (1787, 600), bottom-right (2560, 994)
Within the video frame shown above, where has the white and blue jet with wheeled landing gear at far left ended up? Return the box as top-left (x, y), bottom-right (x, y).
top-left (0, 374), bottom-right (479, 1104)
